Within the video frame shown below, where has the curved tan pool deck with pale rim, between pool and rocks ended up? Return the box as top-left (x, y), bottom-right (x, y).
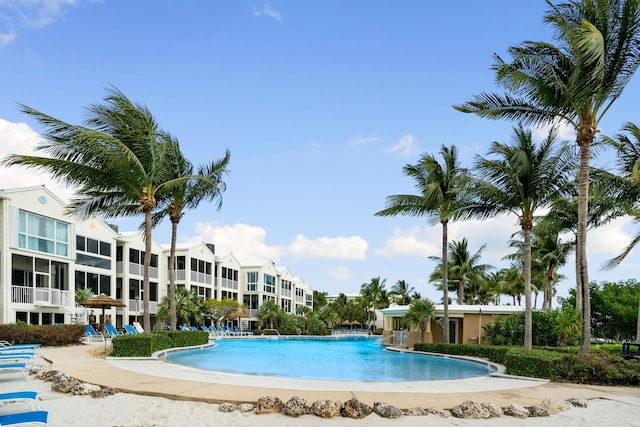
top-left (42, 345), bottom-right (640, 409)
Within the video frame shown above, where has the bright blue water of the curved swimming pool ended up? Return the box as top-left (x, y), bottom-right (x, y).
top-left (166, 337), bottom-right (493, 381)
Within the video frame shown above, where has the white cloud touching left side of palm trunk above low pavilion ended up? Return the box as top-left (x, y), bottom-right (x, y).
top-left (376, 227), bottom-right (442, 258)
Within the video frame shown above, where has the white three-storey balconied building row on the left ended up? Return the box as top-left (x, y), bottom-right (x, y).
top-left (0, 186), bottom-right (313, 328)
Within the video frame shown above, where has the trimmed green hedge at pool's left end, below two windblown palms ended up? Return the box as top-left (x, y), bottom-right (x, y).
top-left (111, 331), bottom-right (209, 357)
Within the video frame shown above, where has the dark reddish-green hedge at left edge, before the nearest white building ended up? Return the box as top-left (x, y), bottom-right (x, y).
top-left (0, 323), bottom-right (85, 346)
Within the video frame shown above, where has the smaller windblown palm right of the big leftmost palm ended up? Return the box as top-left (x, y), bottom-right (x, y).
top-left (152, 134), bottom-right (231, 329)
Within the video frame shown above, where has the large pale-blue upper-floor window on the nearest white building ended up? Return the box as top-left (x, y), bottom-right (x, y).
top-left (18, 211), bottom-right (69, 256)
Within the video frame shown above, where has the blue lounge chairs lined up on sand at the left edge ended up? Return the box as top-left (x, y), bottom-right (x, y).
top-left (0, 340), bottom-right (49, 426)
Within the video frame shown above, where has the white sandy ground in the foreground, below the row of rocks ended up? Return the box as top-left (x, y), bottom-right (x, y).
top-left (0, 352), bottom-right (640, 427)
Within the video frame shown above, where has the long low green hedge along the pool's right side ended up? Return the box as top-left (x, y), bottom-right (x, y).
top-left (414, 343), bottom-right (640, 385)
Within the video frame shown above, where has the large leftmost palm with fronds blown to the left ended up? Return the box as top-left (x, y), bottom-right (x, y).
top-left (2, 87), bottom-right (202, 331)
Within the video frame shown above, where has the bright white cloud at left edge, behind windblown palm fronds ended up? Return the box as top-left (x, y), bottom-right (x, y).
top-left (0, 119), bottom-right (73, 201)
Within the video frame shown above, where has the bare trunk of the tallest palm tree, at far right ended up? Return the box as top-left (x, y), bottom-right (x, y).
top-left (576, 141), bottom-right (591, 354)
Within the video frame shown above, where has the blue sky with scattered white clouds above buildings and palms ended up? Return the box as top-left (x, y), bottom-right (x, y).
top-left (0, 0), bottom-right (640, 307)
